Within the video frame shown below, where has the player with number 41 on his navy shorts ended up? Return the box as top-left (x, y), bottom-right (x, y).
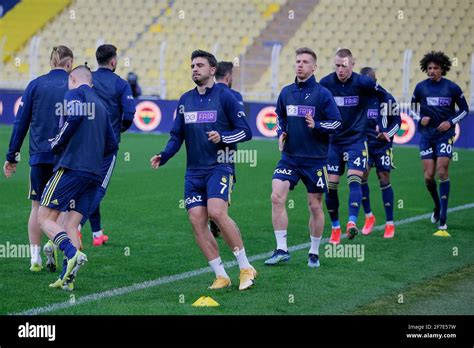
top-left (320, 48), bottom-right (389, 244)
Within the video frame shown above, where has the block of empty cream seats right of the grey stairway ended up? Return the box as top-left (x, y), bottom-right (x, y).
top-left (250, 0), bottom-right (474, 102)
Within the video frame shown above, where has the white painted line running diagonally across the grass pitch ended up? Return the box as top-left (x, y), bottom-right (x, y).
top-left (10, 203), bottom-right (474, 315)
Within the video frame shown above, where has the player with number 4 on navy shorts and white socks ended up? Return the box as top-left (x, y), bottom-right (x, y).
top-left (265, 47), bottom-right (341, 267)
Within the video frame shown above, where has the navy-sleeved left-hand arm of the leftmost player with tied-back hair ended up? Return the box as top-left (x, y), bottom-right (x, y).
top-left (6, 83), bottom-right (35, 163)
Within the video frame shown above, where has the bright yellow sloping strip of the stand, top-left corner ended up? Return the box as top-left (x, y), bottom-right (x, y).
top-left (0, 0), bottom-right (72, 62)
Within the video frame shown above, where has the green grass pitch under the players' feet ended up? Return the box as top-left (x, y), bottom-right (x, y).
top-left (0, 126), bottom-right (474, 315)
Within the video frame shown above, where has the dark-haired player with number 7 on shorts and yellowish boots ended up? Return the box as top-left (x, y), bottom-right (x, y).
top-left (150, 50), bottom-right (257, 290)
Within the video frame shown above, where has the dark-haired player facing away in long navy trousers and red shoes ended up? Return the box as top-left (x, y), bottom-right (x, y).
top-left (79, 44), bottom-right (135, 246)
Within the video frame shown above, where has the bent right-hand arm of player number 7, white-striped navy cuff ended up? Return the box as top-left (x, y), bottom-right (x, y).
top-left (220, 91), bottom-right (252, 144)
